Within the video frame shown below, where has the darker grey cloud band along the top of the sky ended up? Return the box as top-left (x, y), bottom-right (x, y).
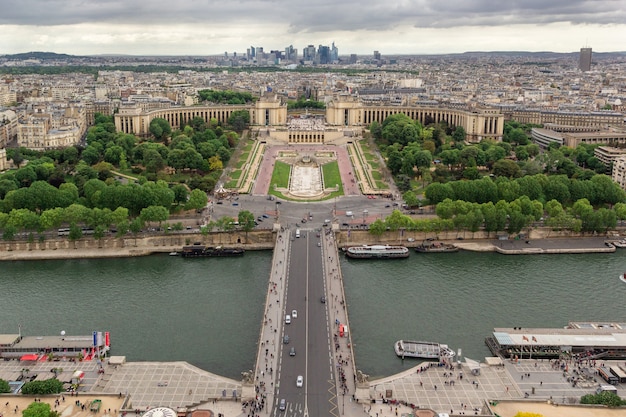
top-left (0, 0), bottom-right (626, 29)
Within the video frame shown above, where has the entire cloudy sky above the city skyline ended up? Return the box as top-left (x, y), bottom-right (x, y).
top-left (0, 0), bottom-right (626, 55)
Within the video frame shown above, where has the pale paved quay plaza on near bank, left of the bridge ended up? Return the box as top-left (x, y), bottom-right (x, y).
top-left (0, 356), bottom-right (241, 417)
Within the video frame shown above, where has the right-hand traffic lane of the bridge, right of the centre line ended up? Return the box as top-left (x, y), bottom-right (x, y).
top-left (307, 237), bottom-right (336, 416)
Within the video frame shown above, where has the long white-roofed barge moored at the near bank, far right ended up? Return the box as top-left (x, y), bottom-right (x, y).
top-left (485, 322), bottom-right (626, 359)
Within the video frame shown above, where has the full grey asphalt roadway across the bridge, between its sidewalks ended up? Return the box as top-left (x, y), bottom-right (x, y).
top-left (273, 230), bottom-right (337, 416)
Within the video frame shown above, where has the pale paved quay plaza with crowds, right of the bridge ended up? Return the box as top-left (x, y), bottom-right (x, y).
top-left (356, 358), bottom-right (626, 417)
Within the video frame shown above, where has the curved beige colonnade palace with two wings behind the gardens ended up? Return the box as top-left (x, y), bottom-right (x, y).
top-left (115, 95), bottom-right (504, 143)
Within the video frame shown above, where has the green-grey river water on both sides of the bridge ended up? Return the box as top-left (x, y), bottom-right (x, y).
top-left (0, 251), bottom-right (626, 378)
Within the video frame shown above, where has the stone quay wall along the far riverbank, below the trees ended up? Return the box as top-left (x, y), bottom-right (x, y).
top-left (0, 230), bottom-right (621, 261)
